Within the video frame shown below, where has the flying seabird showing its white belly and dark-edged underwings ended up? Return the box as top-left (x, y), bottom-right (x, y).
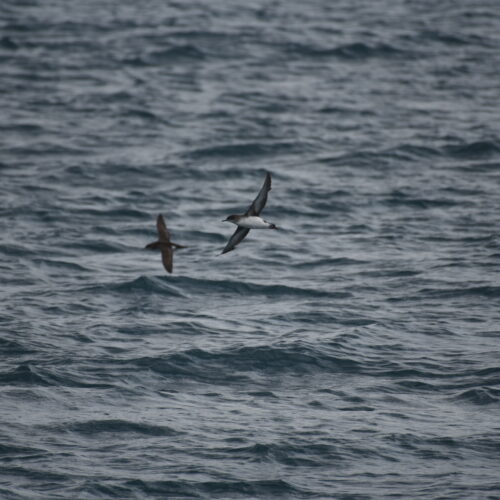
top-left (222, 172), bottom-right (278, 253)
